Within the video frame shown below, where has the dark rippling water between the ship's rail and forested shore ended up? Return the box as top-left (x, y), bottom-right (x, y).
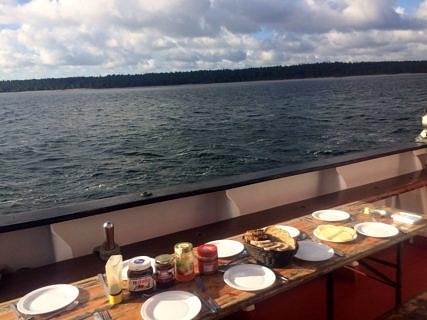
top-left (0, 74), bottom-right (427, 214)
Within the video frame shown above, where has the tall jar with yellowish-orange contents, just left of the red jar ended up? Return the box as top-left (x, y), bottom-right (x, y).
top-left (174, 242), bottom-right (194, 281)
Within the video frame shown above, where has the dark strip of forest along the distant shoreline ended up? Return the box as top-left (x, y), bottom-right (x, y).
top-left (0, 61), bottom-right (427, 92)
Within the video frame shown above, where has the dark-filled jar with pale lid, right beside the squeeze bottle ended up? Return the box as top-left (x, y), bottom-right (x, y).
top-left (128, 256), bottom-right (156, 295)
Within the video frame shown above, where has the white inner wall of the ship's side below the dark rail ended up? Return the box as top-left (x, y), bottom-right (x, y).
top-left (0, 148), bottom-right (427, 269)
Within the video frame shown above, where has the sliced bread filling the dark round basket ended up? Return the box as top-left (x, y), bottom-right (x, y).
top-left (243, 226), bottom-right (296, 251)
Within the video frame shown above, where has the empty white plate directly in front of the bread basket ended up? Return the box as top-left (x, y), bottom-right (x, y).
top-left (224, 264), bottom-right (276, 291)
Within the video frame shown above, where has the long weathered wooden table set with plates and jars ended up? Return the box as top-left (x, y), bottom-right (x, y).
top-left (0, 202), bottom-right (427, 320)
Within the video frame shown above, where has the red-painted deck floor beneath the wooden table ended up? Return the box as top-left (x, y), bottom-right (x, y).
top-left (227, 237), bottom-right (427, 320)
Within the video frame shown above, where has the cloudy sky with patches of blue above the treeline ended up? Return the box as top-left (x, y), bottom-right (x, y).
top-left (0, 0), bottom-right (427, 80)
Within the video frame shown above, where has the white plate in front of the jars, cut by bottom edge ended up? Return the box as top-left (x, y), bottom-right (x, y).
top-left (141, 291), bottom-right (202, 320)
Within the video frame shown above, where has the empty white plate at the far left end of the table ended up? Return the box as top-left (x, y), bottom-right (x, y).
top-left (17, 284), bottom-right (79, 315)
